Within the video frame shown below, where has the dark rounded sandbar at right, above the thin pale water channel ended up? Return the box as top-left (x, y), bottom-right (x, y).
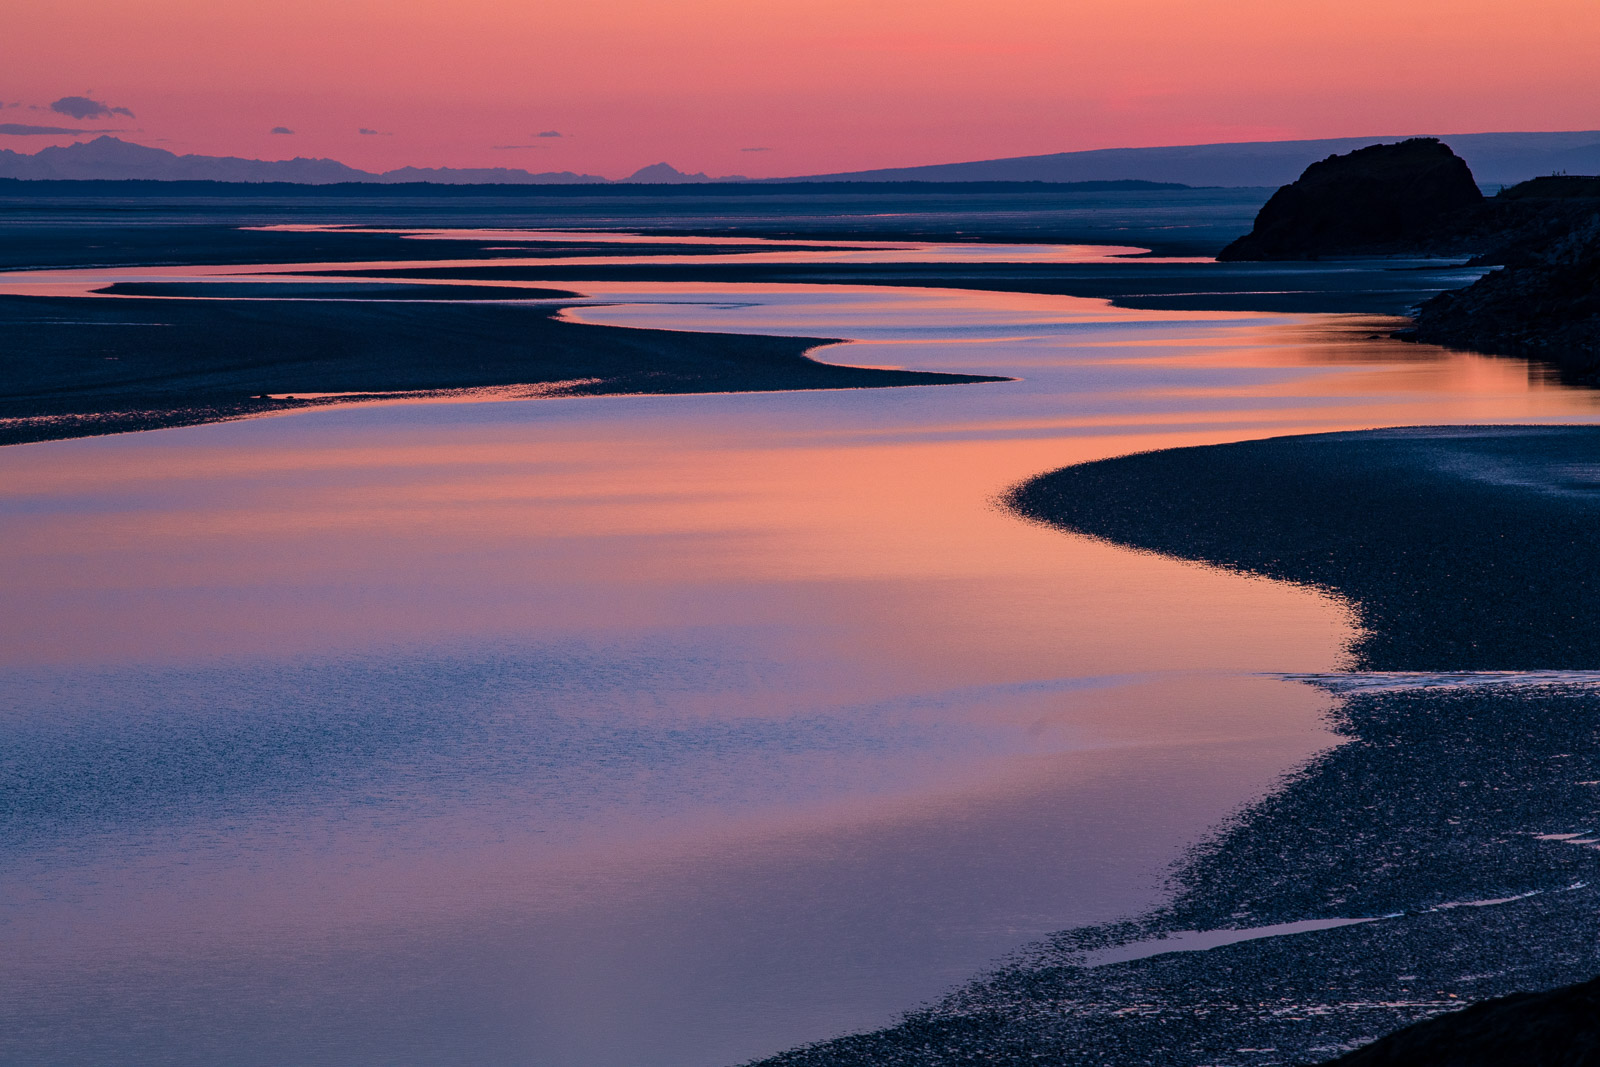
top-left (1010, 426), bottom-right (1600, 670)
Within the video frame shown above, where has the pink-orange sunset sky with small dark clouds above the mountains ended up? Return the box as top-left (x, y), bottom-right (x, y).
top-left (0, 0), bottom-right (1600, 178)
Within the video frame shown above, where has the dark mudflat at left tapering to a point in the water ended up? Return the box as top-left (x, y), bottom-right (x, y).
top-left (0, 283), bottom-right (998, 445)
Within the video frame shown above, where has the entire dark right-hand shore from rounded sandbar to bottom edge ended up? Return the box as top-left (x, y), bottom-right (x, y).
top-left (755, 427), bottom-right (1600, 1067)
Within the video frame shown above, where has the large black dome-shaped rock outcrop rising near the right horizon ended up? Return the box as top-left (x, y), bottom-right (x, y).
top-left (1218, 138), bottom-right (1483, 261)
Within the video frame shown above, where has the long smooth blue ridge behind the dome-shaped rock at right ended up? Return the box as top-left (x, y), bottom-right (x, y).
top-left (773, 130), bottom-right (1600, 187)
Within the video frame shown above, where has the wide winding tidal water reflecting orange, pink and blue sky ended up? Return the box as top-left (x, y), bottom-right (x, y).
top-left (9, 235), bottom-right (1600, 1067)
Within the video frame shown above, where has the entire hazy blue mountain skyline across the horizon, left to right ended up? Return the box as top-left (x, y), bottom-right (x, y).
top-left (0, 130), bottom-right (1600, 187)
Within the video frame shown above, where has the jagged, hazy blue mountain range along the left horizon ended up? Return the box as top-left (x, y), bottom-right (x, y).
top-left (0, 136), bottom-right (605, 186)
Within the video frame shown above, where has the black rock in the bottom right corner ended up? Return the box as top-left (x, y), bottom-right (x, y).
top-left (1328, 979), bottom-right (1600, 1067)
